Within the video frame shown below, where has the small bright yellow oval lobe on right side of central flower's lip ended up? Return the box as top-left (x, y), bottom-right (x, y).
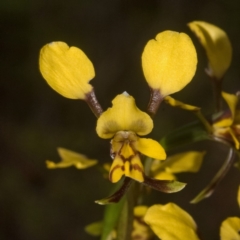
top-left (134, 138), bottom-right (166, 160)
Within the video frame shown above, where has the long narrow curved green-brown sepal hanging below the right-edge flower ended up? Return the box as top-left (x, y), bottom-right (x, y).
top-left (190, 148), bottom-right (235, 204)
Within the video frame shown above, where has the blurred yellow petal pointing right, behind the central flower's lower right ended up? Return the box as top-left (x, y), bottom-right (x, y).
top-left (164, 151), bottom-right (206, 173)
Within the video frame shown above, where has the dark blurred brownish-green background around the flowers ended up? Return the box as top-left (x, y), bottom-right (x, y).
top-left (0, 0), bottom-right (240, 240)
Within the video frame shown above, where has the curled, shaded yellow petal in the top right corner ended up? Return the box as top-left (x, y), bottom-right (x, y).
top-left (188, 21), bottom-right (232, 79)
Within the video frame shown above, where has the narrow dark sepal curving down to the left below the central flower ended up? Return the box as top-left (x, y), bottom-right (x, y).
top-left (95, 177), bottom-right (132, 205)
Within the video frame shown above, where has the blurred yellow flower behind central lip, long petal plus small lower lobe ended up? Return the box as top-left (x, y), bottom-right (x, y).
top-left (151, 151), bottom-right (206, 180)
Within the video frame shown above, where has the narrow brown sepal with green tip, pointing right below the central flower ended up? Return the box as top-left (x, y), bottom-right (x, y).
top-left (143, 176), bottom-right (187, 193)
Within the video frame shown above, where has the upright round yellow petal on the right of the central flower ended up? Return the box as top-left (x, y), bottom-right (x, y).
top-left (142, 31), bottom-right (197, 97)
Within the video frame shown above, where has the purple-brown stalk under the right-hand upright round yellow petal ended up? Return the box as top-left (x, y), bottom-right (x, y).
top-left (147, 88), bottom-right (163, 117)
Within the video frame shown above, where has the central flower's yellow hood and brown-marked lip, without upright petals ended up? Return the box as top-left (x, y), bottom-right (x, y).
top-left (96, 92), bottom-right (166, 182)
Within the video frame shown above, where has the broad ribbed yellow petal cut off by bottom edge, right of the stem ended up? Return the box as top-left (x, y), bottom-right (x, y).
top-left (144, 203), bottom-right (199, 240)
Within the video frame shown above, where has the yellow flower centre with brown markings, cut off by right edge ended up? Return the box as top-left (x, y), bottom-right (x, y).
top-left (213, 92), bottom-right (240, 149)
